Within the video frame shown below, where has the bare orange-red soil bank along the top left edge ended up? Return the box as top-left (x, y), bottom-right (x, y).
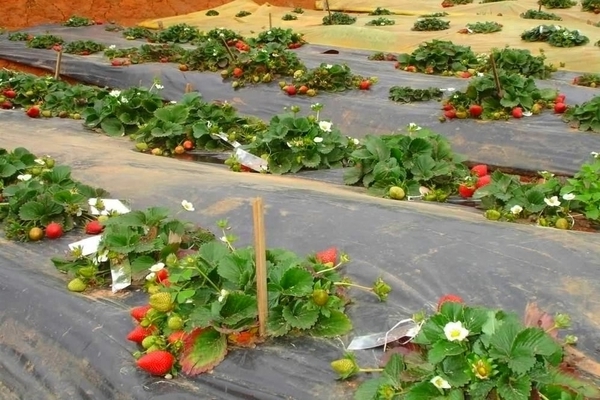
top-left (0, 0), bottom-right (315, 29)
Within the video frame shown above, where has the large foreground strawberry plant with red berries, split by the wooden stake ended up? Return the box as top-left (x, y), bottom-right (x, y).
top-left (120, 217), bottom-right (391, 376)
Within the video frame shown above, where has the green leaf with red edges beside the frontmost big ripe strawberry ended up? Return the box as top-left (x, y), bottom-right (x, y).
top-left (179, 329), bottom-right (227, 376)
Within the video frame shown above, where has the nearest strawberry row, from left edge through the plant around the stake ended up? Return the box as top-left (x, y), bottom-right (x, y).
top-left (0, 148), bottom-right (391, 376)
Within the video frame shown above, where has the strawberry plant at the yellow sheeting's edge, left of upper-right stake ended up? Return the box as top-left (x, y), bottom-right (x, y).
top-left (398, 39), bottom-right (478, 75)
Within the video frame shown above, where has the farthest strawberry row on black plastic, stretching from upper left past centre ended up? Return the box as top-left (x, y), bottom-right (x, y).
top-left (9, 24), bottom-right (377, 96)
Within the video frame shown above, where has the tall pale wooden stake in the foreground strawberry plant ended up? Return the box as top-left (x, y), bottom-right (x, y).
top-left (252, 197), bottom-right (269, 337)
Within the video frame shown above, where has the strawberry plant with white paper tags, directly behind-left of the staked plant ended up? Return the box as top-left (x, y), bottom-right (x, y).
top-left (52, 203), bottom-right (215, 291)
